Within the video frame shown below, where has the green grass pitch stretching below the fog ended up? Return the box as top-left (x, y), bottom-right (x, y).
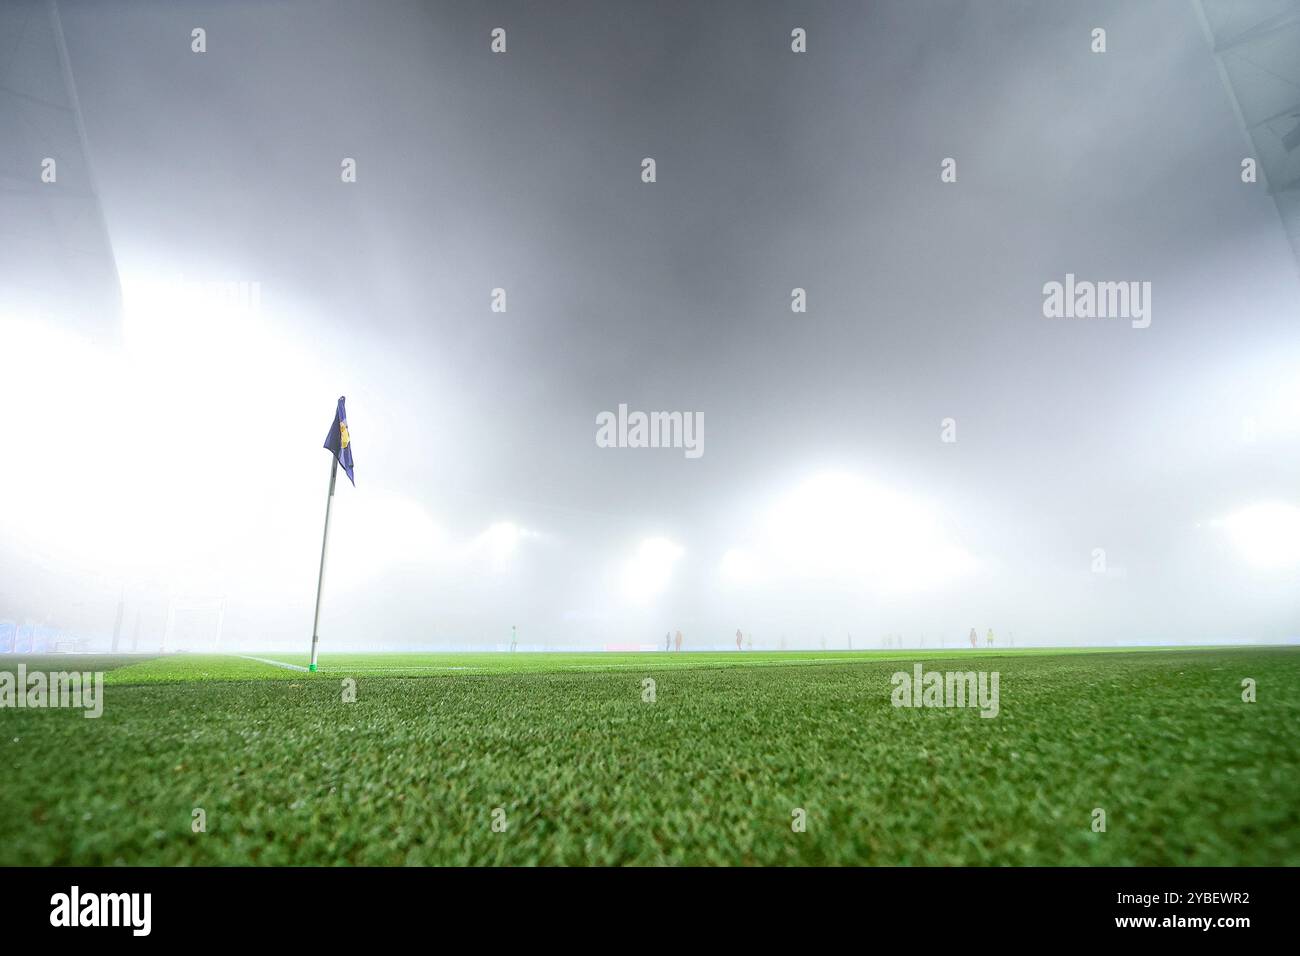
top-left (0, 648), bottom-right (1300, 865)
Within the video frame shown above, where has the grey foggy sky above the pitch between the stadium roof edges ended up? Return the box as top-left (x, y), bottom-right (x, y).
top-left (2, 0), bottom-right (1300, 645)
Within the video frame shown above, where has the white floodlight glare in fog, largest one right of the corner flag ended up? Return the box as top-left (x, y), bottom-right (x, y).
top-left (766, 473), bottom-right (975, 591)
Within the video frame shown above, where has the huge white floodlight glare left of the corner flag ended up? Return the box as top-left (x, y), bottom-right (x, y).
top-left (0, 265), bottom-right (334, 593)
